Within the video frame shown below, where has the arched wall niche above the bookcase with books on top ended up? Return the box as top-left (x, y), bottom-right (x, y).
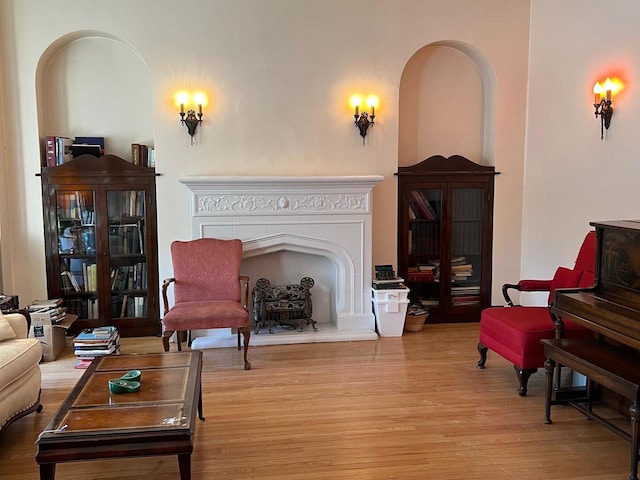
top-left (36, 31), bottom-right (153, 160)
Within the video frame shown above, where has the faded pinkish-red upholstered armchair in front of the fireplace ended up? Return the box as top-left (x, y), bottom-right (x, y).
top-left (162, 238), bottom-right (251, 370)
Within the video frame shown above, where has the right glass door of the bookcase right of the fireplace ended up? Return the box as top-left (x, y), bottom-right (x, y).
top-left (451, 188), bottom-right (484, 306)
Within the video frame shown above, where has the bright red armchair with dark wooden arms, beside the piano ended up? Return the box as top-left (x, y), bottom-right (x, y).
top-left (478, 231), bottom-right (596, 396)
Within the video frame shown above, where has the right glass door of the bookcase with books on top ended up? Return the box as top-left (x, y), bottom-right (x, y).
top-left (107, 190), bottom-right (147, 318)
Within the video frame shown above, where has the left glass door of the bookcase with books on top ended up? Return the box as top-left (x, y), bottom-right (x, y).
top-left (55, 190), bottom-right (98, 318)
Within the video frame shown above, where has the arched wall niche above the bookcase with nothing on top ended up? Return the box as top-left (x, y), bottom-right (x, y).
top-left (398, 41), bottom-right (496, 166)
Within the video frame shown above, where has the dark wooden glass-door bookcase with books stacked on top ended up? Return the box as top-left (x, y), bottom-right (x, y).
top-left (40, 155), bottom-right (160, 336)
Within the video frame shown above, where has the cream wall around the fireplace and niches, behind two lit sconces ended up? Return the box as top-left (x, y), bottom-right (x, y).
top-left (0, 0), bottom-right (528, 303)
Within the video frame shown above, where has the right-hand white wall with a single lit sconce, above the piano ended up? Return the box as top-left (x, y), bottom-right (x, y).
top-left (522, 0), bottom-right (640, 304)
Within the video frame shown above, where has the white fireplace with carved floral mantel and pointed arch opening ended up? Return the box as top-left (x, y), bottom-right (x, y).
top-left (180, 175), bottom-right (383, 348)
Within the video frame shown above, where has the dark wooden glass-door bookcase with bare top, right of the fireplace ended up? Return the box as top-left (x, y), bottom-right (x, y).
top-left (396, 155), bottom-right (496, 323)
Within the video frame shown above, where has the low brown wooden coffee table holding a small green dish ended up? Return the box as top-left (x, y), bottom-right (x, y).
top-left (36, 351), bottom-right (204, 480)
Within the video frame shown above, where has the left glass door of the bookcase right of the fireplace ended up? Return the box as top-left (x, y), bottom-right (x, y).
top-left (405, 188), bottom-right (443, 307)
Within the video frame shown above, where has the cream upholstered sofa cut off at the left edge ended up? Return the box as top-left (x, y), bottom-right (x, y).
top-left (0, 313), bottom-right (42, 433)
